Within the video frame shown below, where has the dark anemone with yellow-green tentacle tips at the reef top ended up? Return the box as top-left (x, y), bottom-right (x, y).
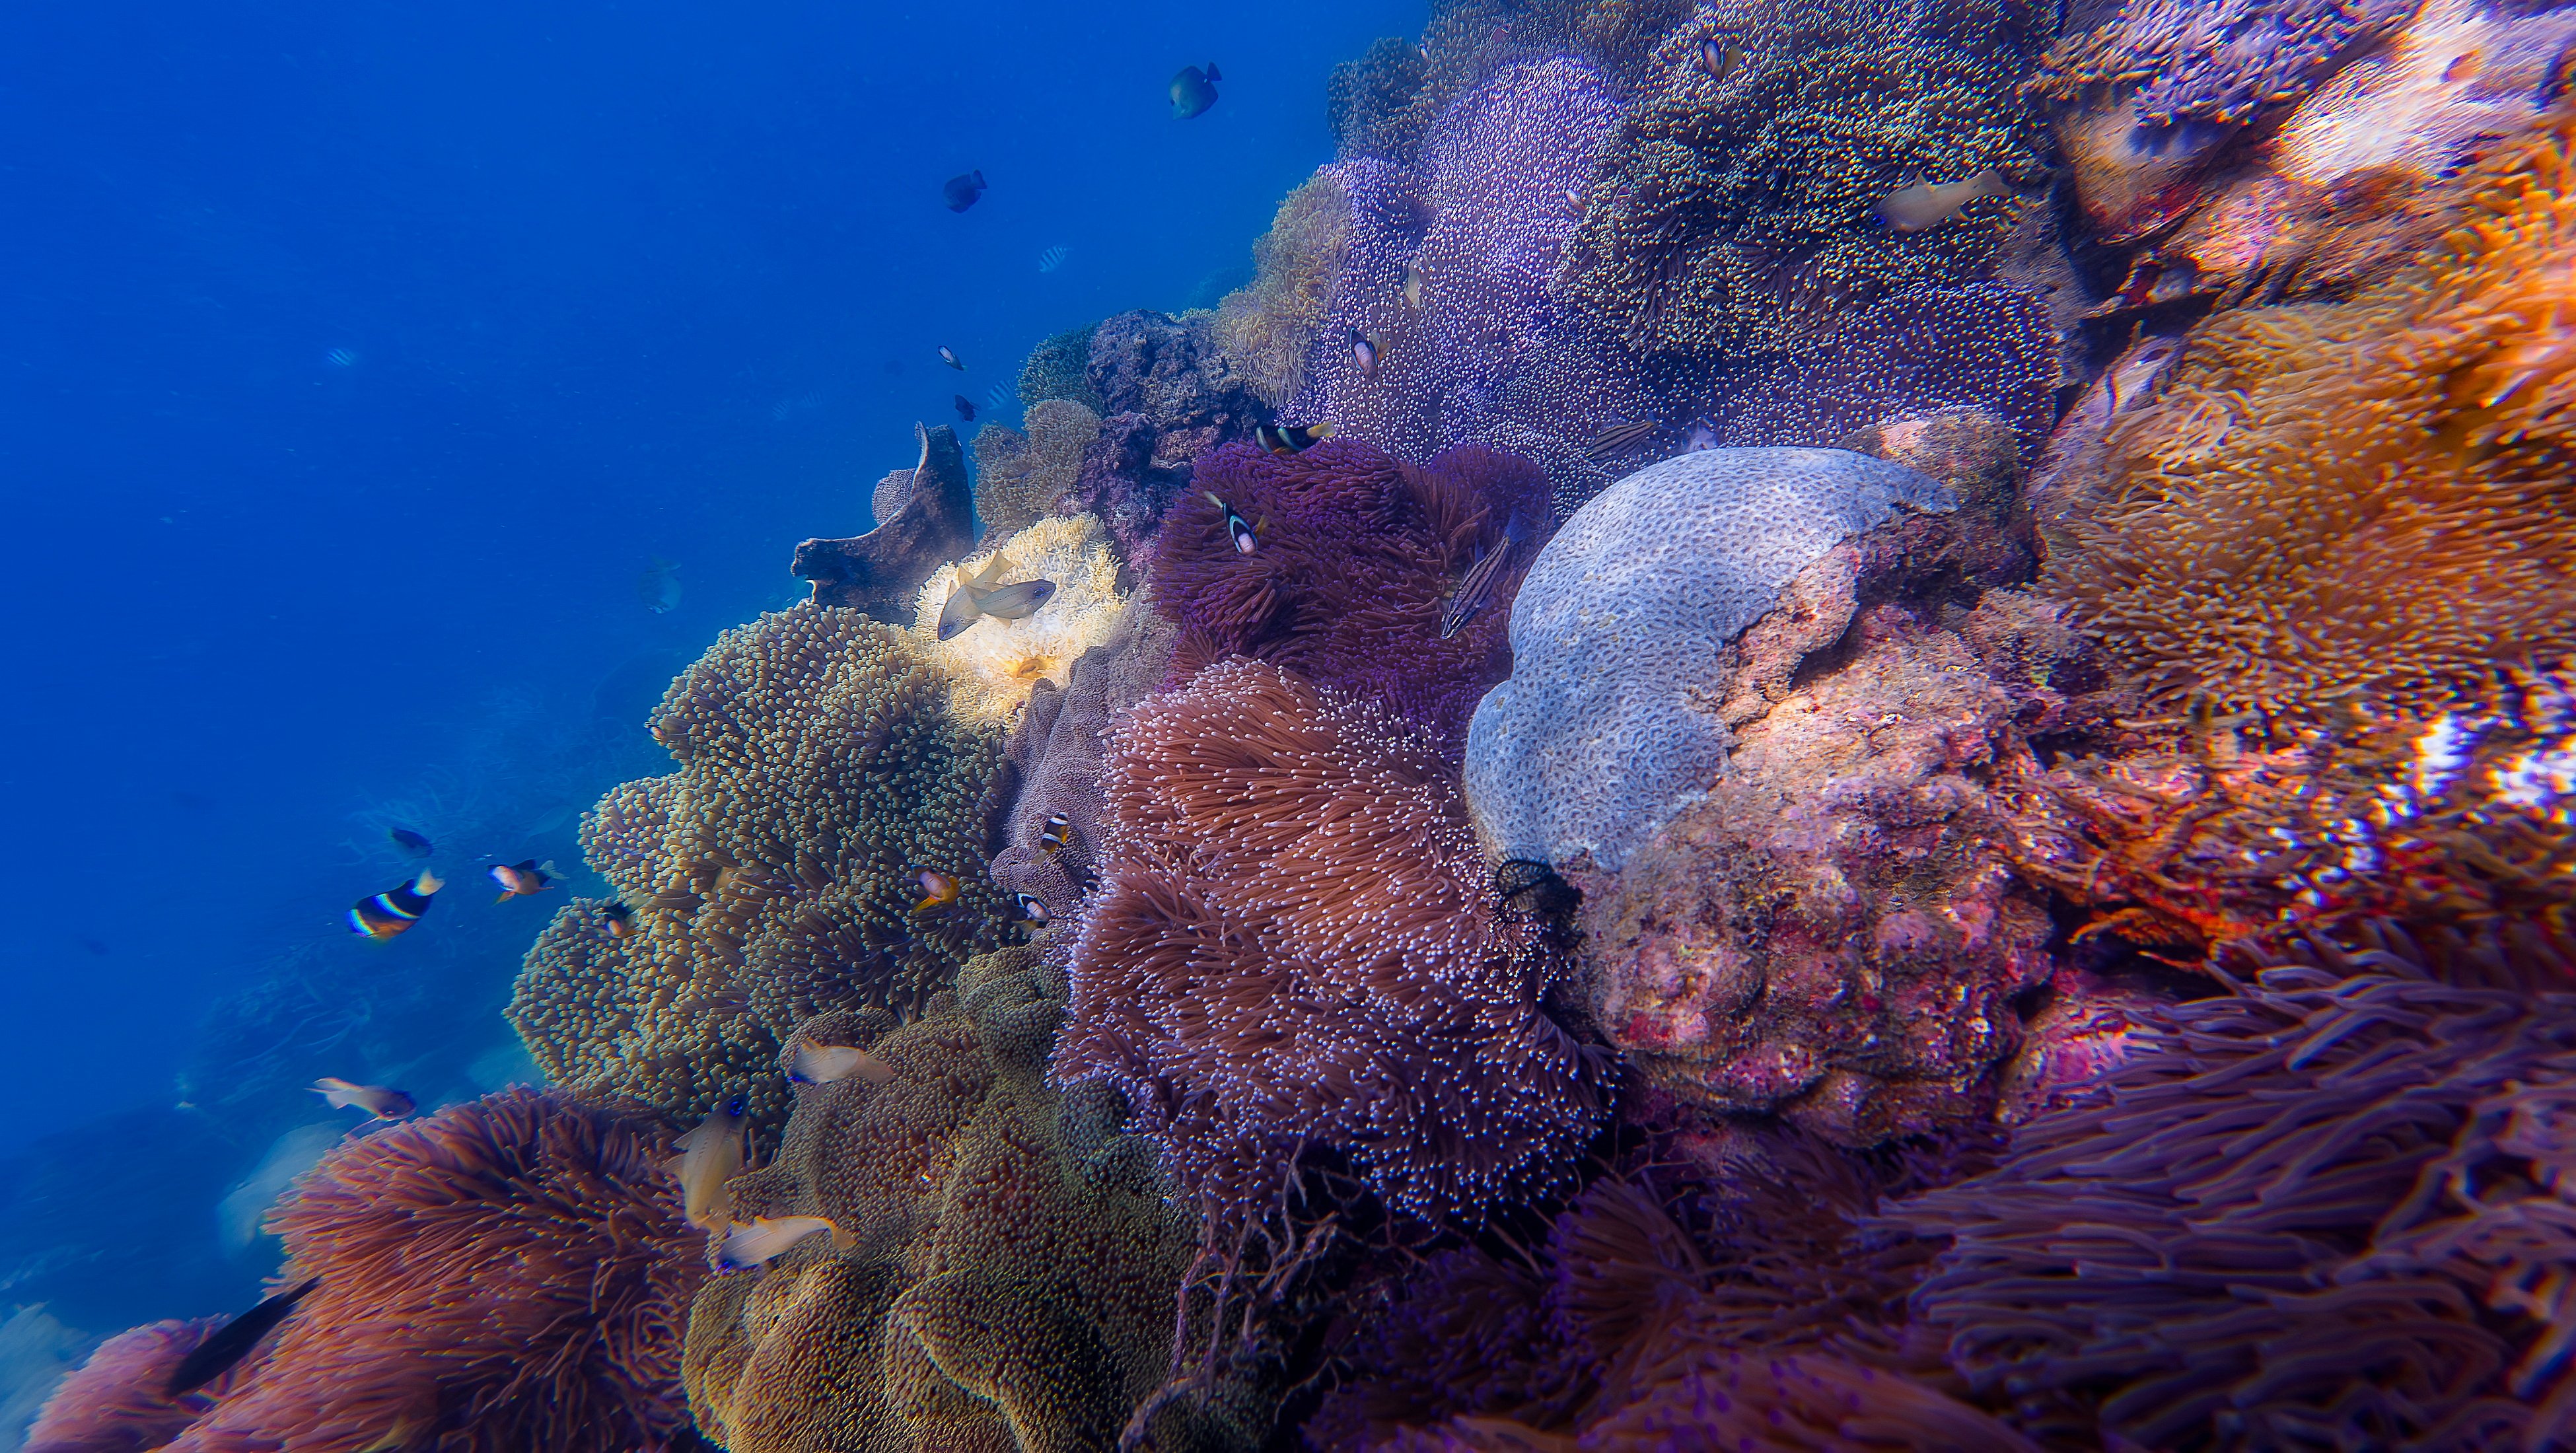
top-left (1559, 0), bottom-right (2048, 358)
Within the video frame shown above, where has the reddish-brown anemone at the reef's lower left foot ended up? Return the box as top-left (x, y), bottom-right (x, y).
top-left (145, 1090), bottom-right (706, 1453)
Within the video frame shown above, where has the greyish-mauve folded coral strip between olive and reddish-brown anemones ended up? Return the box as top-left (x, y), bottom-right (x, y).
top-left (992, 610), bottom-right (1180, 917)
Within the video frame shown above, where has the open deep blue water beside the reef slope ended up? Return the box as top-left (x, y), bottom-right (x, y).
top-left (0, 0), bottom-right (1422, 1370)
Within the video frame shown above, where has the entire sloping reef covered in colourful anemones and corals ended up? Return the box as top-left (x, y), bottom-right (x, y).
top-left (85, 0), bottom-right (2576, 1453)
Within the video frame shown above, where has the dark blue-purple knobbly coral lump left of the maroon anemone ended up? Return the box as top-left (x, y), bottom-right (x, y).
top-left (1069, 312), bottom-right (1270, 569)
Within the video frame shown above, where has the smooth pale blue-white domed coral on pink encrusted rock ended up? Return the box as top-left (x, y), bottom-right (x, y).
top-left (1466, 448), bottom-right (1955, 870)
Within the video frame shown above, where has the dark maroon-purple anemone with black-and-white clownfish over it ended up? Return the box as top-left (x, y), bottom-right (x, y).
top-left (1147, 438), bottom-right (1548, 755)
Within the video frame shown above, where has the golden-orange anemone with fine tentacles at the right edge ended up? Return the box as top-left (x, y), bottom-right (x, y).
top-left (2048, 147), bottom-right (2576, 711)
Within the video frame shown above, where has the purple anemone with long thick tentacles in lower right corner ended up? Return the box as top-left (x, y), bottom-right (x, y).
top-left (1891, 950), bottom-right (2576, 1450)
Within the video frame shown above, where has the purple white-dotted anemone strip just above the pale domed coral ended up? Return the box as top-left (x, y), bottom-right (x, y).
top-left (1715, 283), bottom-right (2058, 448)
